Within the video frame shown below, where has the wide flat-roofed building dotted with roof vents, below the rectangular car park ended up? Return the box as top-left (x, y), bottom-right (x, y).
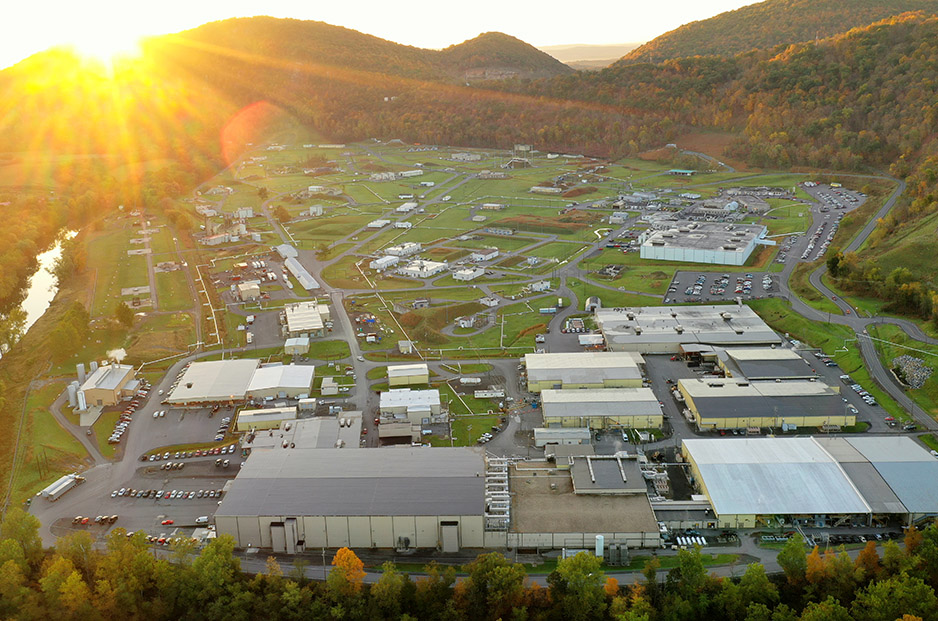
top-left (594, 304), bottom-right (782, 354)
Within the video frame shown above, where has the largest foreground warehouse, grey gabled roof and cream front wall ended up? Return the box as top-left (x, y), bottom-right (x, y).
top-left (215, 448), bottom-right (485, 553)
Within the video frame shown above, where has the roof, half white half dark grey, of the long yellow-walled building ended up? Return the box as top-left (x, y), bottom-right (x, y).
top-left (678, 378), bottom-right (845, 422)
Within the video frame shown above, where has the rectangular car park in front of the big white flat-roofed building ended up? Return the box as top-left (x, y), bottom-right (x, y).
top-left (664, 272), bottom-right (778, 304)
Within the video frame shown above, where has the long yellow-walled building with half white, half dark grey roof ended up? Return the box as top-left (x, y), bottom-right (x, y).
top-left (677, 378), bottom-right (856, 430)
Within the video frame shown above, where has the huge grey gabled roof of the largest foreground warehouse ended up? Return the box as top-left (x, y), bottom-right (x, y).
top-left (215, 447), bottom-right (485, 517)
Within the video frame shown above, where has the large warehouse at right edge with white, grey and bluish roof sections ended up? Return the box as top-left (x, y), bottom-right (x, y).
top-left (683, 436), bottom-right (938, 528)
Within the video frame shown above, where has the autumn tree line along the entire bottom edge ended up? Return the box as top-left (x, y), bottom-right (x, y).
top-left (0, 508), bottom-right (938, 621)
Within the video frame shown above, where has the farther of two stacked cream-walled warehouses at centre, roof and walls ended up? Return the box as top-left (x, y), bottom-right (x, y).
top-left (524, 352), bottom-right (644, 392)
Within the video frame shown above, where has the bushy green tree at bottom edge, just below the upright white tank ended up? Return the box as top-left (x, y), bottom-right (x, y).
top-left (547, 552), bottom-right (606, 620)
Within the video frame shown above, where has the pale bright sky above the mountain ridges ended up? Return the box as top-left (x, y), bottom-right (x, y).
top-left (0, 0), bottom-right (753, 67)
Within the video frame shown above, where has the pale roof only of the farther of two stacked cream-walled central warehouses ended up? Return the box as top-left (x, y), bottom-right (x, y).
top-left (524, 351), bottom-right (642, 384)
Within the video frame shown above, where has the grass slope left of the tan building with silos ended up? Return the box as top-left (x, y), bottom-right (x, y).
top-left (12, 382), bottom-right (88, 502)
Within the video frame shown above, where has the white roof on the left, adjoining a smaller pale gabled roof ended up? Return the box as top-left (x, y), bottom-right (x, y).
top-left (166, 358), bottom-right (260, 403)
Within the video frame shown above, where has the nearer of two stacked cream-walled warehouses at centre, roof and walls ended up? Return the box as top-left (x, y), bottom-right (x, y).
top-left (541, 388), bottom-right (663, 429)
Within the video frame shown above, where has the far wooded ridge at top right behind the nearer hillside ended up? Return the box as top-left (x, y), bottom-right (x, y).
top-left (621, 0), bottom-right (938, 64)
